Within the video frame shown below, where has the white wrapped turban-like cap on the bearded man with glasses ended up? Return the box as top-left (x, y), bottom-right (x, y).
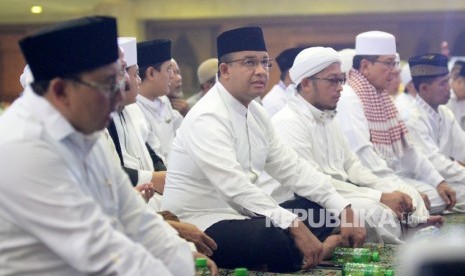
top-left (289, 47), bottom-right (341, 85)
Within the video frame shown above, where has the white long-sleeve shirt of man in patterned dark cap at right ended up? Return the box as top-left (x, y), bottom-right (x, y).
top-left (406, 96), bottom-right (465, 184)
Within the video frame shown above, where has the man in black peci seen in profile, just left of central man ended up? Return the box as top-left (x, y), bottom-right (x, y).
top-left (137, 39), bottom-right (183, 167)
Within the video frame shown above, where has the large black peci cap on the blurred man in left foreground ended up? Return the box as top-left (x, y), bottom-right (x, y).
top-left (19, 16), bottom-right (118, 81)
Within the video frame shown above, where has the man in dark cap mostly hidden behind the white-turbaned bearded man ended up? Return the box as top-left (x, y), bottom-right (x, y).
top-left (262, 47), bottom-right (304, 117)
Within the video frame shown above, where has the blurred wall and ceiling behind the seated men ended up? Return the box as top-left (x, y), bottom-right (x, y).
top-left (0, 0), bottom-right (465, 102)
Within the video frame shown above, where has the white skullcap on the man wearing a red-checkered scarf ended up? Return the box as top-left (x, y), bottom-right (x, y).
top-left (355, 31), bottom-right (396, 56)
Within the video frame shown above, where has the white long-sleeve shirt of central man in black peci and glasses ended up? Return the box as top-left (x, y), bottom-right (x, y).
top-left (162, 82), bottom-right (348, 230)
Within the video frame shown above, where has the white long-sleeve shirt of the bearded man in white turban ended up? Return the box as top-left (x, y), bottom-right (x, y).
top-left (272, 94), bottom-right (388, 202)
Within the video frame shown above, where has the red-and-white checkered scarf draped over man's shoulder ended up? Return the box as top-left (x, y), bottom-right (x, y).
top-left (347, 68), bottom-right (411, 160)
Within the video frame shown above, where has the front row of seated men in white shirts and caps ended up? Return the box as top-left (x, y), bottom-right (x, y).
top-left (0, 14), bottom-right (465, 275)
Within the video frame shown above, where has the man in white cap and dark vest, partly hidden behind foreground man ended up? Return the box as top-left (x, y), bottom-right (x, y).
top-left (108, 37), bottom-right (216, 255)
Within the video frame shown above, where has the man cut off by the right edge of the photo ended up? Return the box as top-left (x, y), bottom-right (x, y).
top-left (447, 60), bottom-right (465, 130)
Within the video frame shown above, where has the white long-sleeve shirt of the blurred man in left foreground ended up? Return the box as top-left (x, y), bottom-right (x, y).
top-left (0, 87), bottom-right (194, 275)
